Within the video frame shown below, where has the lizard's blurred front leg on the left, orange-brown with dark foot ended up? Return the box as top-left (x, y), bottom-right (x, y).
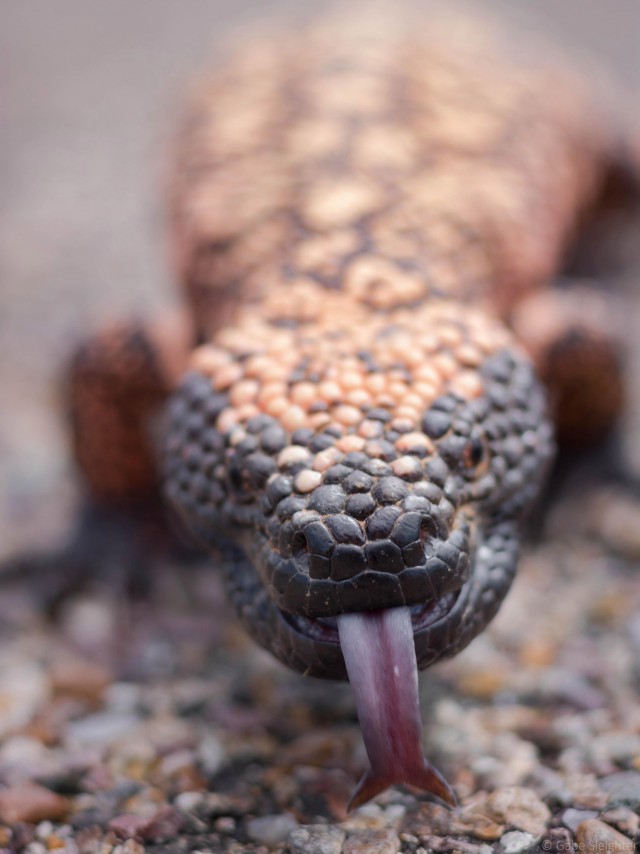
top-left (1, 312), bottom-right (192, 612)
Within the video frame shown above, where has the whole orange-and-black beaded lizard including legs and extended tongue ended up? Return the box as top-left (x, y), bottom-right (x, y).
top-left (26, 15), bottom-right (636, 808)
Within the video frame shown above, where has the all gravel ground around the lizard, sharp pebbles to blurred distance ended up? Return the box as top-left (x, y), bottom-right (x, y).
top-left (0, 0), bottom-right (640, 854)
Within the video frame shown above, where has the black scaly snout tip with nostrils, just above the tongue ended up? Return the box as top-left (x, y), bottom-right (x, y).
top-left (269, 502), bottom-right (471, 617)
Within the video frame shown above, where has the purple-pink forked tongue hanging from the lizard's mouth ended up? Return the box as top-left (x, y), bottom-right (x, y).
top-left (338, 608), bottom-right (456, 810)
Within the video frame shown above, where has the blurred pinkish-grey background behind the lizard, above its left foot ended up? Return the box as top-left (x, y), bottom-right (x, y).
top-left (0, 0), bottom-right (640, 554)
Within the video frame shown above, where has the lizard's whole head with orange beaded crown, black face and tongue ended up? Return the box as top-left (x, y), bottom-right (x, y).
top-left (166, 301), bottom-right (553, 803)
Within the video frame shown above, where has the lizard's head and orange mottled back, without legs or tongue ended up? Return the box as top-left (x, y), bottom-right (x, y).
top-left (158, 18), bottom-right (606, 678)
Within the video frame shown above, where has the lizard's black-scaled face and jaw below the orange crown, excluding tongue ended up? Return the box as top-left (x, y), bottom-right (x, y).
top-left (167, 342), bottom-right (552, 678)
